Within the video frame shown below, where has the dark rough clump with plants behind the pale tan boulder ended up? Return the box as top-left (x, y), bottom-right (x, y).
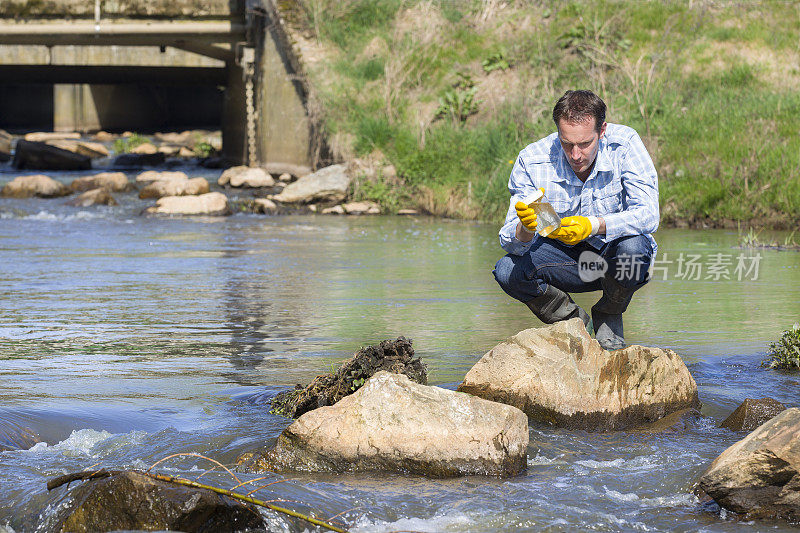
top-left (270, 337), bottom-right (428, 418)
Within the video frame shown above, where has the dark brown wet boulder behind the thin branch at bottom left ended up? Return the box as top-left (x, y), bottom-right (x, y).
top-left (47, 471), bottom-right (266, 533)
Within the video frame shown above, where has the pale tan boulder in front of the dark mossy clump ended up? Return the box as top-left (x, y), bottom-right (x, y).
top-left (243, 371), bottom-right (528, 477)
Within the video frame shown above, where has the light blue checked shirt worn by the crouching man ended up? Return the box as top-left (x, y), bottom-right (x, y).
top-left (500, 124), bottom-right (659, 255)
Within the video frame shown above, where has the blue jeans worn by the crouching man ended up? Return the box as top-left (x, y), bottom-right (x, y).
top-left (494, 235), bottom-right (653, 303)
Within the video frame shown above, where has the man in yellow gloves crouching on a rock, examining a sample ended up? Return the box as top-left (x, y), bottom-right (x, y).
top-left (494, 91), bottom-right (659, 350)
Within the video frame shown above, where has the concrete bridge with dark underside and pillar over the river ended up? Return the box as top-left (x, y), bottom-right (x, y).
top-left (0, 0), bottom-right (318, 169)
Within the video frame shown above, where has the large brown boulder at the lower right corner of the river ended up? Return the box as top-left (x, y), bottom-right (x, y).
top-left (697, 408), bottom-right (800, 522)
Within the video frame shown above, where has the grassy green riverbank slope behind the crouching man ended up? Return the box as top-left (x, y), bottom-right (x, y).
top-left (276, 0), bottom-right (800, 229)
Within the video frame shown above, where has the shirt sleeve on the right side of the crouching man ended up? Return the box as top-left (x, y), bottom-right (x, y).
top-left (603, 133), bottom-right (659, 241)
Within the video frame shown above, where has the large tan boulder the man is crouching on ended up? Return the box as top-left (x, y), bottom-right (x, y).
top-left (458, 318), bottom-right (699, 431)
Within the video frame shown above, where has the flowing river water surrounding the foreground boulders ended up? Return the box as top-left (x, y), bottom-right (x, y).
top-left (0, 164), bottom-right (800, 533)
